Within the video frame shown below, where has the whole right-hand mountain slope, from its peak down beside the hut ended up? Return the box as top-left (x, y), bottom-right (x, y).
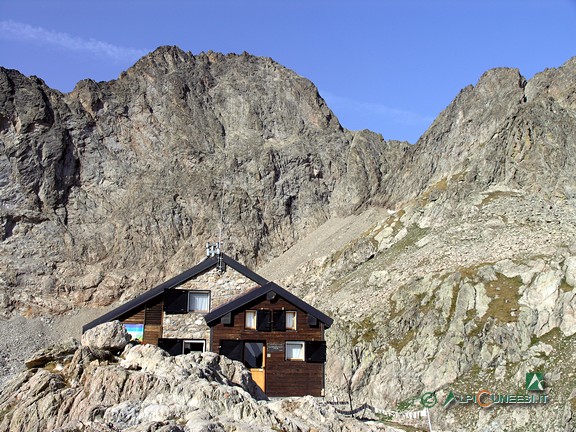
top-left (279, 60), bottom-right (576, 430)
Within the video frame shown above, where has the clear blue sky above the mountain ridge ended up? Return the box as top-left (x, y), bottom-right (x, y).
top-left (0, 0), bottom-right (576, 142)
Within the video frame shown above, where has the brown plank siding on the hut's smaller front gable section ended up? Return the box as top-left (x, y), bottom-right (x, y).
top-left (211, 297), bottom-right (324, 396)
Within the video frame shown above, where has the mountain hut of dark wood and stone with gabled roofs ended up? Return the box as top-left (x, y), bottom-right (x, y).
top-left (83, 252), bottom-right (332, 396)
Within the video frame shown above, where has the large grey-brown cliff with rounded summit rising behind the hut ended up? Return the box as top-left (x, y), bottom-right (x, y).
top-left (0, 47), bottom-right (407, 315)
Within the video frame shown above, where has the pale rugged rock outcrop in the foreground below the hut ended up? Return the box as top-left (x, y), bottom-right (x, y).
top-left (0, 340), bottom-right (391, 432)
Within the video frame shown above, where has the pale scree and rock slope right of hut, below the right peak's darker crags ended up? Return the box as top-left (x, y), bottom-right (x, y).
top-left (283, 171), bottom-right (576, 431)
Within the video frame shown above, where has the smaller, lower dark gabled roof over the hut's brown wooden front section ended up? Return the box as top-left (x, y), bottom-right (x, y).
top-left (204, 282), bottom-right (333, 328)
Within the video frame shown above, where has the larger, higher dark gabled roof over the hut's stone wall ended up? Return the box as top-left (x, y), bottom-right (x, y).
top-left (82, 254), bottom-right (268, 332)
